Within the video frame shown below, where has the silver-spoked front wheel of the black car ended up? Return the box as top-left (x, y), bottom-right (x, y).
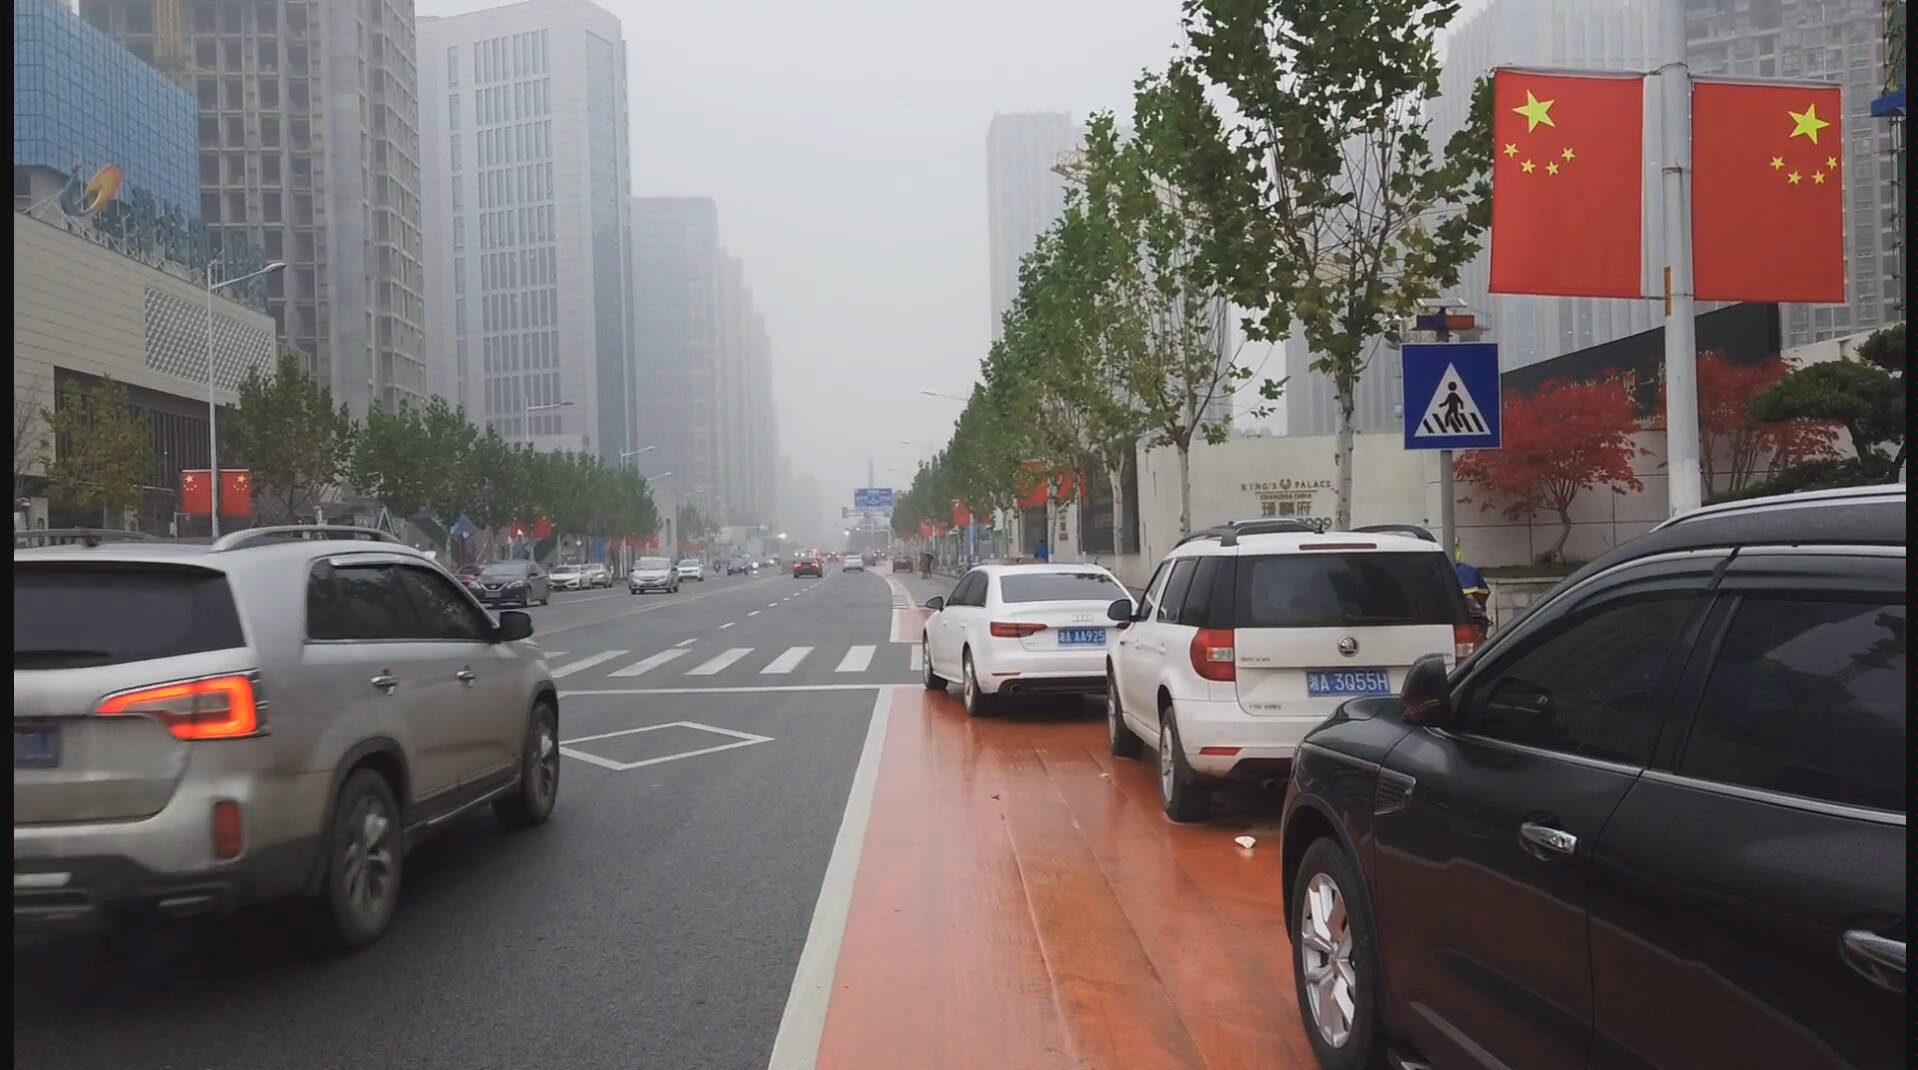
top-left (1285, 838), bottom-right (1385, 1070)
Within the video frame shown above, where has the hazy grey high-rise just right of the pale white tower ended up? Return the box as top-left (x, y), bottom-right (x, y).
top-left (631, 198), bottom-right (777, 523)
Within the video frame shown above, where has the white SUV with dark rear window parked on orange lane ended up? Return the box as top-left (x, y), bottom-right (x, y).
top-left (1107, 522), bottom-right (1481, 821)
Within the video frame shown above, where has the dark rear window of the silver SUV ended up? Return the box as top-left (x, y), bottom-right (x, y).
top-left (13, 560), bottom-right (246, 669)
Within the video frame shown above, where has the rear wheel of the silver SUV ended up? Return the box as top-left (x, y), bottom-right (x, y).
top-left (315, 769), bottom-right (407, 951)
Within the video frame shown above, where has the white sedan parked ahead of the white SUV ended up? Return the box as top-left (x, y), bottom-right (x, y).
top-left (921, 564), bottom-right (1132, 717)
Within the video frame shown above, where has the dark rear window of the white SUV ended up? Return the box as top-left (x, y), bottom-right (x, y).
top-left (1233, 550), bottom-right (1469, 627)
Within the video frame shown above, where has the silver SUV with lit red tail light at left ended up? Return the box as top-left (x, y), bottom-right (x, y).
top-left (13, 527), bottom-right (560, 949)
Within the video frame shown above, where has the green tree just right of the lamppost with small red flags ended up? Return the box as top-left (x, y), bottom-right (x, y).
top-left (221, 351), bottom-right (355, 518)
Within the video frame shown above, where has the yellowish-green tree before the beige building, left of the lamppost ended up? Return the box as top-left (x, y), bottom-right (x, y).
top-left (40, 378), bottom-right (157, 527)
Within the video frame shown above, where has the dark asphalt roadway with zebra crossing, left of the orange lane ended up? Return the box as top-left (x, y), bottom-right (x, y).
top-left (13, 571), bottom-right (917, 1070)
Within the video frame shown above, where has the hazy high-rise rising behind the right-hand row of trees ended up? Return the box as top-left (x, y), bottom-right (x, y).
top-left (986, 111), bottom-right (1080, 341)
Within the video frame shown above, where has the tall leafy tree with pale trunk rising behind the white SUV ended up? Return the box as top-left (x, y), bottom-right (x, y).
top-left (1135, 0), bottom-right (1492, 527)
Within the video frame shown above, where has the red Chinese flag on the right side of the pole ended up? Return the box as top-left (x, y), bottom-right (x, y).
top-left (1692, 82), bottom-right (1845, 305)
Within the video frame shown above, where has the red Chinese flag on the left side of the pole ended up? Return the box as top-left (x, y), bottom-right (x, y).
top-left (1490, 71), bottom-right (1646, 297)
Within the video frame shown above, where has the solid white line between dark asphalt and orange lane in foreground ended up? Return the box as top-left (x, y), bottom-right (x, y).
top-left (767, 690), bottom-right (892, 1070)
